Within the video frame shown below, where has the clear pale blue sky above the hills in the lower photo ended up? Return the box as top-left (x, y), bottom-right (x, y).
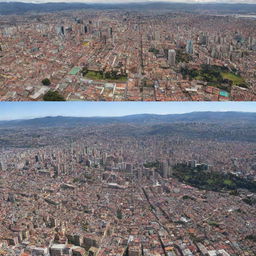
top-left (0, 101), bottom-right (256, 120)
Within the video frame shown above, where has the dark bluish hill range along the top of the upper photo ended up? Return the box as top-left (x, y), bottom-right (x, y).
top-left (0, 2), bottom-right (256, 15)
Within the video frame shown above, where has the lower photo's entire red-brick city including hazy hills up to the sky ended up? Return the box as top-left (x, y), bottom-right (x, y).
top-left (0, 112), bottom-right (256, 256)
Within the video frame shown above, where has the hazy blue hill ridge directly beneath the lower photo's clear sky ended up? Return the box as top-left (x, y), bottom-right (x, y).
top-left (0, 112), bottom-right (256, 128)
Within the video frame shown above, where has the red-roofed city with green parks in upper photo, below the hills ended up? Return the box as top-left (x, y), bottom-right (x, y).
top-left (0, 5), bottom-right (256, 101)
